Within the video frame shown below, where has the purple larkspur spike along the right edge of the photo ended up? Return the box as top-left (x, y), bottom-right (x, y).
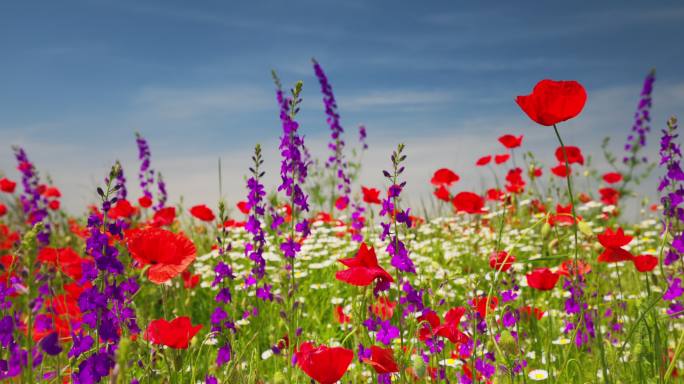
top-left (658, 117), bottom-right (684, 317)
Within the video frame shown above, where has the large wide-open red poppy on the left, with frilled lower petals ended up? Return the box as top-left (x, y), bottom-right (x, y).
top-left (127, 228), bottom-right (196, 284)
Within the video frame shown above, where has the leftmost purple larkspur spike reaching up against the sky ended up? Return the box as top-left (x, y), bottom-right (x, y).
top-left (13, 147), bottom-right (50, 245)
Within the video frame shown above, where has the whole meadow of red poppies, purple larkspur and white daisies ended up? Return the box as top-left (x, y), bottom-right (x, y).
top-left (0, 64), bottom-right (684, 384)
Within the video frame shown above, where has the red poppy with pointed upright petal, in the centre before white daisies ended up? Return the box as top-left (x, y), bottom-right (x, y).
top-left (335, 243), bottom-right (394, 287)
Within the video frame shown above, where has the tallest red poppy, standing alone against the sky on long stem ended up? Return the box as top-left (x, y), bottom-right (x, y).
top-left (515, 79), bottom-right (587, 126)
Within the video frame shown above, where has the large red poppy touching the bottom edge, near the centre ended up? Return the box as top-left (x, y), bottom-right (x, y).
top-left (295, 343), bottom-right (354, 384)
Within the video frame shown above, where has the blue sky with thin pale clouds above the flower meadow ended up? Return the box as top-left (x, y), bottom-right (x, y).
top-left (0, 1), bottom-right (684, 211)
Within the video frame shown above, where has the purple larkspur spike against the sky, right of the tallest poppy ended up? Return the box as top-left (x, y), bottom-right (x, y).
top-left (622, 70), bottom-right (655, 166)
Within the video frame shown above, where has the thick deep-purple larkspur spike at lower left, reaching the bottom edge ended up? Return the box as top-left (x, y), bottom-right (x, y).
top-left (69, 166), bottom-right (140, 384)
